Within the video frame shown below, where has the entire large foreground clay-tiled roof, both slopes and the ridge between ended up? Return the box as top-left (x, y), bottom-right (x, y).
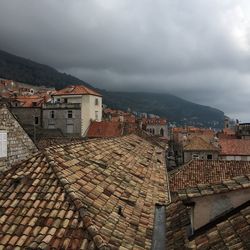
top-left (0, 135), bottom-right (169, 249)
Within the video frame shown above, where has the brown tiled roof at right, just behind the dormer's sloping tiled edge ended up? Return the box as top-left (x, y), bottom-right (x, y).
top-left (169, 160), bottom-right (250, 192)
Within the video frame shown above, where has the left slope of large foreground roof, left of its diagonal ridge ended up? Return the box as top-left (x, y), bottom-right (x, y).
top-left (0, 153), bottom-right (101, 249)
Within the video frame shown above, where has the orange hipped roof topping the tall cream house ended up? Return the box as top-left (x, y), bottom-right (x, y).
top-left (53, 85), bottom-right (102, 96)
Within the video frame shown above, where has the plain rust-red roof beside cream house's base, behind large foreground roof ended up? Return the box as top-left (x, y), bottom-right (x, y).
top-left (87, 121), bottom-right (122, 138)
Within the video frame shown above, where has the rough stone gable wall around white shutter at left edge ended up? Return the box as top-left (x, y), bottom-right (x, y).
top-left (0, 105), bottom-right (37, 172)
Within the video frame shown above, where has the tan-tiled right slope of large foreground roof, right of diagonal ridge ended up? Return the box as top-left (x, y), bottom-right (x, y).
top-left (47, 135), bottom-right (168, 249)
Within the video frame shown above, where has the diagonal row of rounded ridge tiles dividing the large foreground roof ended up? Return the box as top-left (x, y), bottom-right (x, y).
top-left (44, 149), bottom-right (111, 250)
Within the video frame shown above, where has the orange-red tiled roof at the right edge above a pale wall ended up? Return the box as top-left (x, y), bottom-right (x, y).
top-left (219, 139), bottom-right (250, 155)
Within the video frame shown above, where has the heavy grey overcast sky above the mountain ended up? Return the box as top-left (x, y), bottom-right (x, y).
top-left (0, 0), bottom-right (250, 122)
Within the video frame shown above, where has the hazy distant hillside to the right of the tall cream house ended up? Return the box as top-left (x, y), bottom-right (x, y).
top-left (103, 91), bottom-right (224, 128)
